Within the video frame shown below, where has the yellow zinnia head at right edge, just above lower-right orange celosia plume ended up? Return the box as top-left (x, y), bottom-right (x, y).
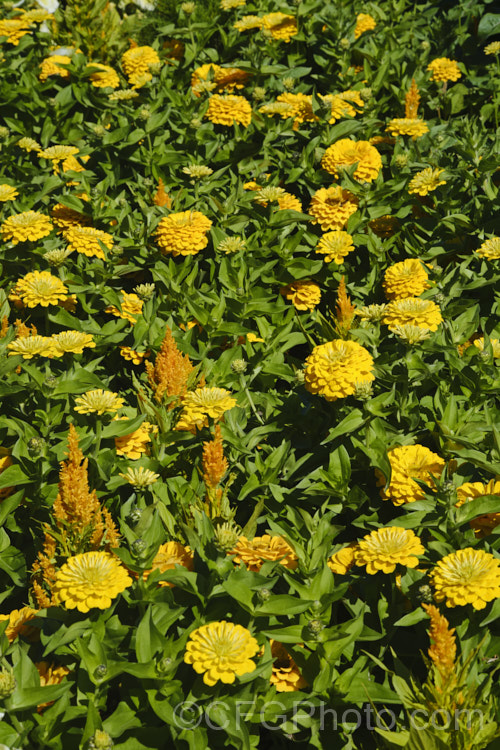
top-left (430, 547), bottom-right (500, 609)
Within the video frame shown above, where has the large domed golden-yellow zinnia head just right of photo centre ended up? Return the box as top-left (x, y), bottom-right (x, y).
top-left (304, 339), bottom-right (375, 401)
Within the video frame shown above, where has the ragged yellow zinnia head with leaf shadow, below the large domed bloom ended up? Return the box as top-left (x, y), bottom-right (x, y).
top-left (375, 444), bottom-right (445, 505)
